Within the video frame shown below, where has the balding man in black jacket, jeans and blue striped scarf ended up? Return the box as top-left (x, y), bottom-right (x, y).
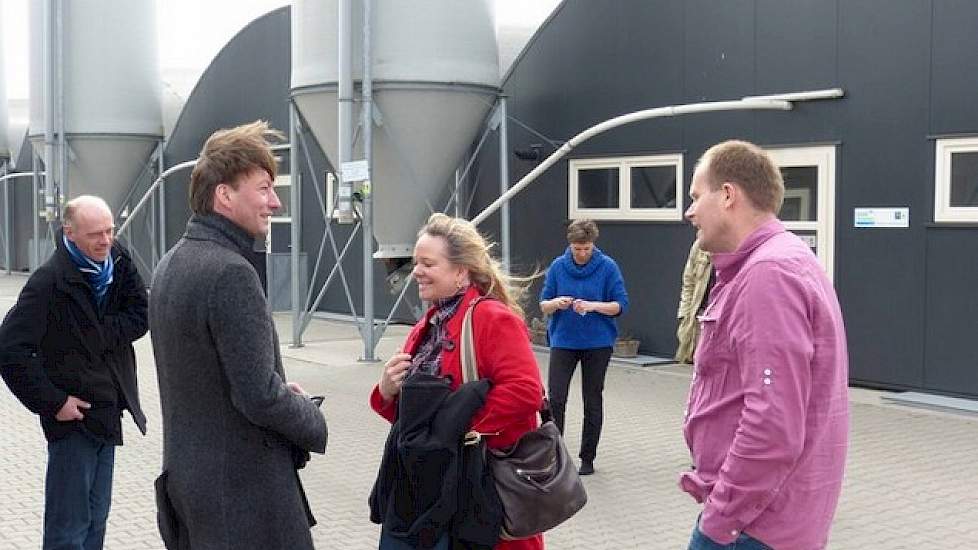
top-left (0, 195), bottom-right (148, 550)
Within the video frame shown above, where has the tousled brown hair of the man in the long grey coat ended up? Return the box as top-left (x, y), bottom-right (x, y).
top-left (190, 120), bottom-right (285, 214)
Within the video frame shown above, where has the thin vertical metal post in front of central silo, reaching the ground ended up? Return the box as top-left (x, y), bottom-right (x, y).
top-left (360, 0), bottom-right (377, 361)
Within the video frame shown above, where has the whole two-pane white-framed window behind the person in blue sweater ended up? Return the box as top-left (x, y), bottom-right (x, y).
top-left (568, 154), bottom-right (683, 221)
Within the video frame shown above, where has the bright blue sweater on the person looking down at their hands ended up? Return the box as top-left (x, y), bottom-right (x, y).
top-left (540, 247), bottom-right (628, 349)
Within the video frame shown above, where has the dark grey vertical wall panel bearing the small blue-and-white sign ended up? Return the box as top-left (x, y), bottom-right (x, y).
top-left (836, 0), bottom-right (933, 387)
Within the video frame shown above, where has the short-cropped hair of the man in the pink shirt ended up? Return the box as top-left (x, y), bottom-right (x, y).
top-left (699, 139), bottom-right (784, 214)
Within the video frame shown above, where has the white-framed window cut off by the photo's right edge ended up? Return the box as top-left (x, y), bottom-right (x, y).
top-left (934, 137), bottom-right (978, 222)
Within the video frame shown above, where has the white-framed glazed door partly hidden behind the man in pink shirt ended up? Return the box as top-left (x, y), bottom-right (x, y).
top-left (767, 145), bottom-right (835, 279)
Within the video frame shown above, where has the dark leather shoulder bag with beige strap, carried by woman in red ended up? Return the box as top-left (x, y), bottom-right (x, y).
top-left (460, 298), bottom-right (587, 540)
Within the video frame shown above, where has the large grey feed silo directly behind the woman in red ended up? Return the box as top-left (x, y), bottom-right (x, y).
top-left (291, 0), bottom-right (499, 258)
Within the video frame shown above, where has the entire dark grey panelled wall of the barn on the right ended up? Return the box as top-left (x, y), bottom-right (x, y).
top-left (484, 0), bottom-right (978, 393)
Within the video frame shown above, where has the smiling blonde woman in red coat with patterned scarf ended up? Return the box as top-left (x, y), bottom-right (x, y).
top-left (370, 214), bottom-right (544, 550)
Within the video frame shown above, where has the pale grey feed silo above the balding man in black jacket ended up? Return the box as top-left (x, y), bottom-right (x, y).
top-left (30, 0), bottom-right (163, 212)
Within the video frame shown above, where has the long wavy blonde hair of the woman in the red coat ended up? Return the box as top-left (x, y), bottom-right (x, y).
top-left (418, 213), bottom-right (528, 319)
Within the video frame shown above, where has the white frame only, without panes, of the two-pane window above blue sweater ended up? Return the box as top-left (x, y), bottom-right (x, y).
top-left (567, 153), bottom-right (684, 222)
